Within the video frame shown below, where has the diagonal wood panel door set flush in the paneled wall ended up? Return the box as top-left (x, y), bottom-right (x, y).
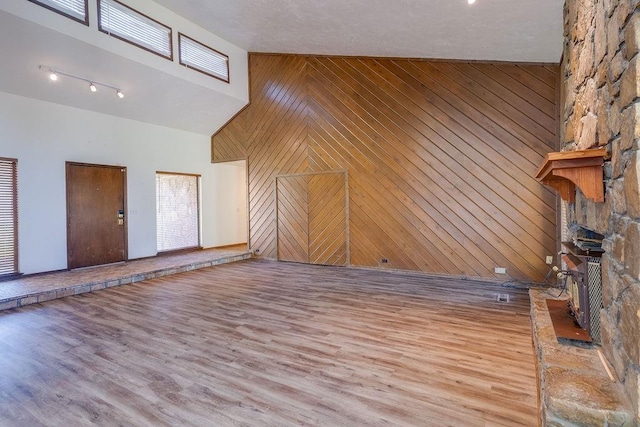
top-left (276, 172), bottom-right (349, 265)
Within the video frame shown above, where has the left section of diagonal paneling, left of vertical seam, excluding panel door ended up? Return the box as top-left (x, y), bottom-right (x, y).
top-left (211, 55), bottom-right (308, 258)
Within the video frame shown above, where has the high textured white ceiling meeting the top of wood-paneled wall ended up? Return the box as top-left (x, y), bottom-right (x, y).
top-left (156, 0), bottom-right (564, 63)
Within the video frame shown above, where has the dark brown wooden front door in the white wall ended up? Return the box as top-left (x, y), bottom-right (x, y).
top-left (66, 162), bottom-right (127, 269)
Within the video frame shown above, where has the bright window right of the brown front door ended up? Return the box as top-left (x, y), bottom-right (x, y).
top-left (156, 172), bottom-right (200, 252)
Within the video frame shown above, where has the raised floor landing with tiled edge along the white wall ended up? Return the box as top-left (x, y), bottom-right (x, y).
top-left (0, 244), bottom-right (251, 310)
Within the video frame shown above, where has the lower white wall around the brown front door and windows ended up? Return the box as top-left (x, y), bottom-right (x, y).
top-left (0, 92), bottom-right (246, 274)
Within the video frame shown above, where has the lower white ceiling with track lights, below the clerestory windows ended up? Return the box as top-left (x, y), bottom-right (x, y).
top-left (0, 10), bottom-right (244, 135)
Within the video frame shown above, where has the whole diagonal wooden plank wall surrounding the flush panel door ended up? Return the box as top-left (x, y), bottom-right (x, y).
top-left (212, 54), bottom-right (558, 280)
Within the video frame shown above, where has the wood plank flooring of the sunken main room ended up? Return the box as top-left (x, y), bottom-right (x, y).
top-left (0, 260), bottom-right (537, 426)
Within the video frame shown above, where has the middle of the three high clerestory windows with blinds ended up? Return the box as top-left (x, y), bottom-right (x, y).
top-left (98, 0), bottom-right (173, 60)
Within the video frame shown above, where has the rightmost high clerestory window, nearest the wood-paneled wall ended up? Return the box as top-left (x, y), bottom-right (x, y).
top-left (178, 33), bottom-right (229, 83)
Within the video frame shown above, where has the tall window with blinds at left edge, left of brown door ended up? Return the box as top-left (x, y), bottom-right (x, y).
top-left (0, 158), bottom-right (18, 276)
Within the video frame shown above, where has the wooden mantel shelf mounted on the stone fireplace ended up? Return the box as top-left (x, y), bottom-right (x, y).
top-left (536, 148), bottom-right (607, 203)
